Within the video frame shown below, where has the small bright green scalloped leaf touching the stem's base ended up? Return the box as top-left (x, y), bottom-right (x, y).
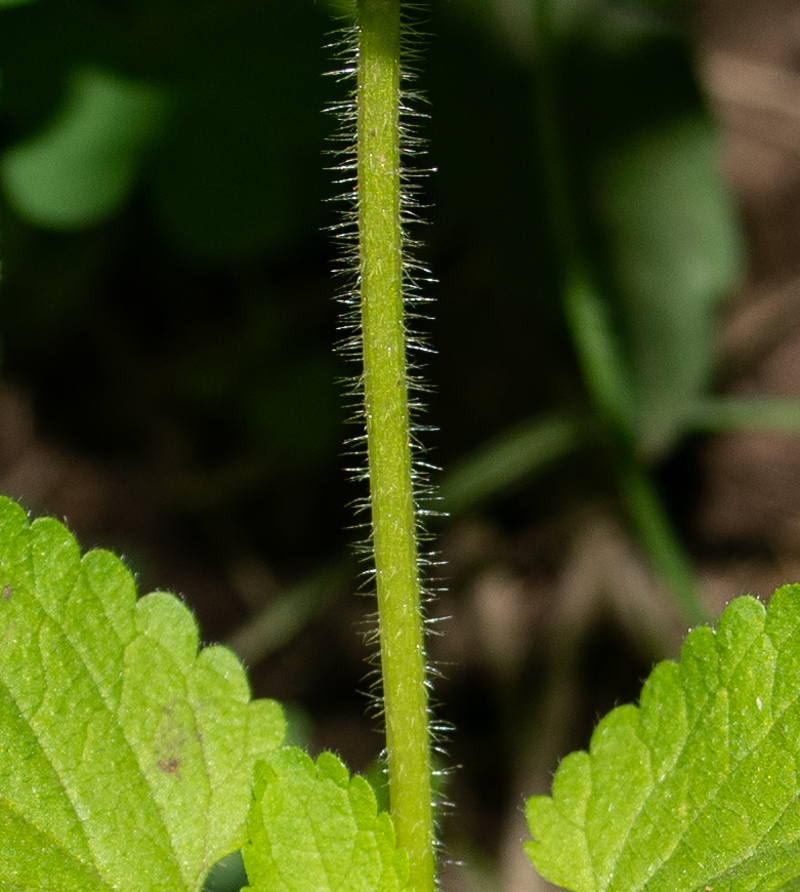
top-left (244, 747), bottom-right (408, 892)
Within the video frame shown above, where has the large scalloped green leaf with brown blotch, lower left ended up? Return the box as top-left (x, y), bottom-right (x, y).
top-left (0, 499), bottom-right (284, 892)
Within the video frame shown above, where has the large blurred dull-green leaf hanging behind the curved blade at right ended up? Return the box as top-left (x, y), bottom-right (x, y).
top-left (598, 114), bottom-right (742, 454)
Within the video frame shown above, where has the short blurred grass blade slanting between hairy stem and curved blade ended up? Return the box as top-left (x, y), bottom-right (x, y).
top-left (440, 416), bottom-right (587, 514)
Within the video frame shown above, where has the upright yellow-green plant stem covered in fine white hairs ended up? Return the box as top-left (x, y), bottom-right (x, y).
top-left (357, 0), bottom-right (435, 892)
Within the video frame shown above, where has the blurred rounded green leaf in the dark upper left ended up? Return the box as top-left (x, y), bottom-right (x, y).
top-left (0, 69), bottom-right (165, 229)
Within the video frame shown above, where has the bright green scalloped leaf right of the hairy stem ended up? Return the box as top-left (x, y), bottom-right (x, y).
top-left (525, 585), bottom-right (800, 892)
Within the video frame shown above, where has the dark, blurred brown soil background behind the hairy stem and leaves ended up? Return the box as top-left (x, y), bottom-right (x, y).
top-left (0, 0), bottom-right (800, 892)
